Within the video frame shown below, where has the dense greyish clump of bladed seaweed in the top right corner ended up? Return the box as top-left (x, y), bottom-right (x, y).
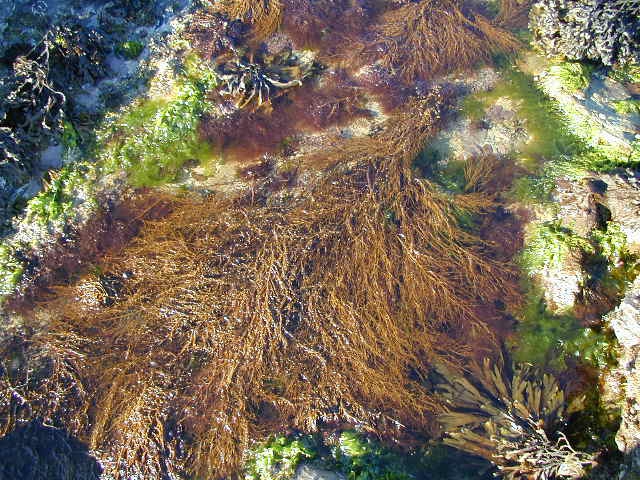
top-left (530, 0), bottom-right (640, 65)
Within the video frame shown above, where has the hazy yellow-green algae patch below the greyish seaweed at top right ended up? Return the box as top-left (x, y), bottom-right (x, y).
top-left (461, 63), bottom-right (640, 203)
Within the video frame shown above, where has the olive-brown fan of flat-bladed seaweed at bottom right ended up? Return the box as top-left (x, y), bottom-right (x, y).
top-left (439, 359), bottom-right (592, 480)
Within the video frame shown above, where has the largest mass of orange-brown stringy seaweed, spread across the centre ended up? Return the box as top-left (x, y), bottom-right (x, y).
top-left (5, 87), bottom-right (515, 478)
